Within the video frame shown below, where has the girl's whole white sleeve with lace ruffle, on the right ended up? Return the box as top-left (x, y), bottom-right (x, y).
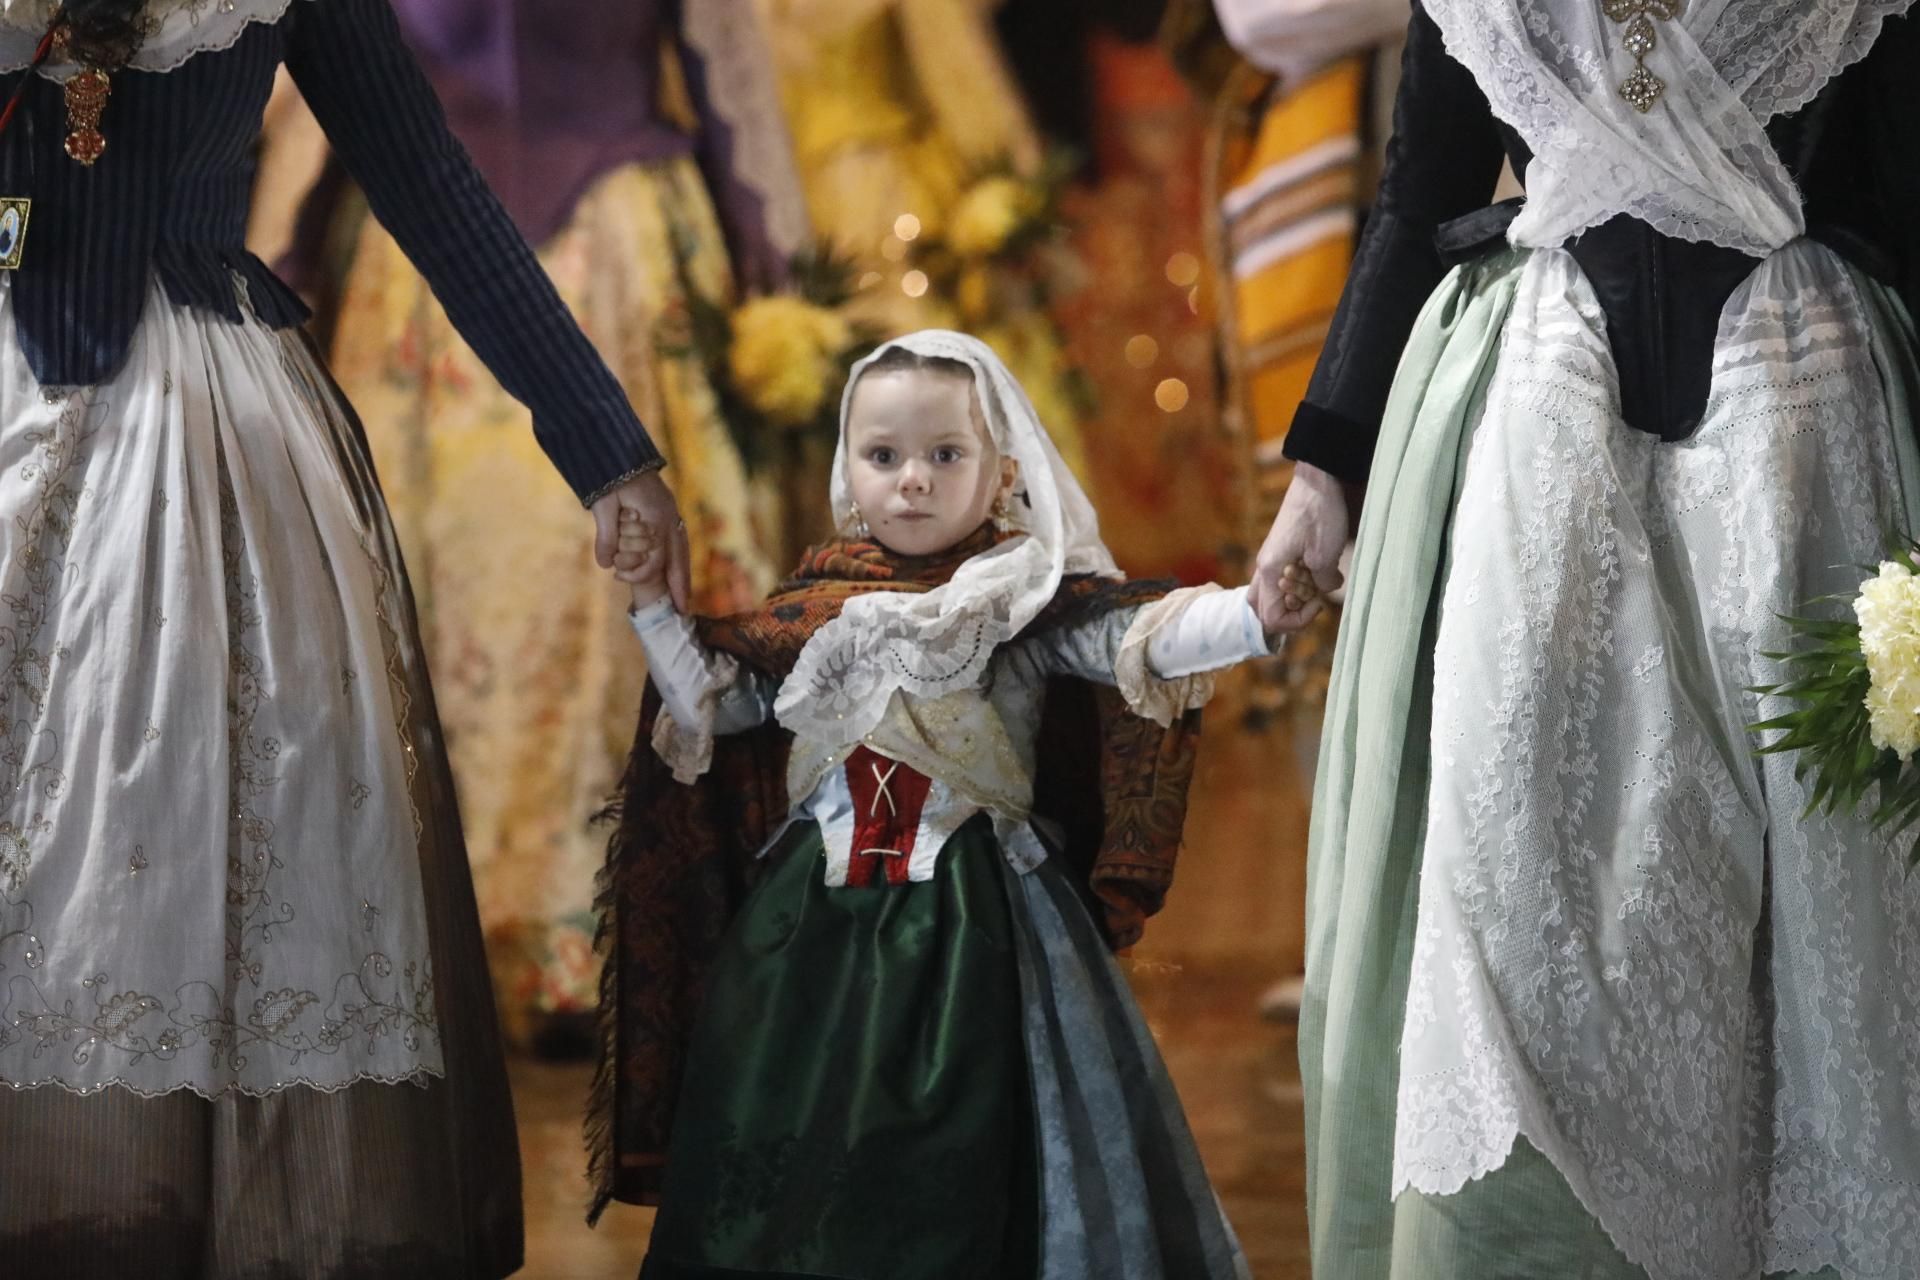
top-left (1035, 583), bottom-right (1269, 723)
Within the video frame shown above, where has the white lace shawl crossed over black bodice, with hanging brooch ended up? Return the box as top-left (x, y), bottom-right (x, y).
top-left (1427, 0), bottom-right (1914, 257)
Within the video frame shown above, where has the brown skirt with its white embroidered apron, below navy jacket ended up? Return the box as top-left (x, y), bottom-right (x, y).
top-left (0, 284), bottom-right (520, 1280)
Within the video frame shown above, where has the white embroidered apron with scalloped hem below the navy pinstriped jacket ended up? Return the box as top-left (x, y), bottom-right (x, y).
top-left (0, 288), bottom-right (439, 1096)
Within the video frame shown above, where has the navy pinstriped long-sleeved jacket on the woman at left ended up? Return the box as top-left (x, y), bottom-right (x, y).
top-left (0, 0), bottom-right (662, 501)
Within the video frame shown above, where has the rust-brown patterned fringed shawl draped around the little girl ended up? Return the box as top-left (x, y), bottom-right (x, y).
top-left (588, 528), bottom-right (1200, 1221)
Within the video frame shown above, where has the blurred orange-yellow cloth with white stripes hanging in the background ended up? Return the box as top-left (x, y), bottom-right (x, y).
top-left (1217, 56), bottom-right (1367, 526)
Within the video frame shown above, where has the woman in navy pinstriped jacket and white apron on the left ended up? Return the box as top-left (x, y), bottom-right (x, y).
top-left (0, 0), bottom-right (684, 1280)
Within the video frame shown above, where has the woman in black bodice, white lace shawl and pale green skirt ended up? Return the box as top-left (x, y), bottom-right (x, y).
top-left (1254, 0), bottom-right (1920, 1280)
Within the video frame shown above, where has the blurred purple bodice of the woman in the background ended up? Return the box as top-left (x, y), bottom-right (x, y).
top-left (394, 0), bottom-right (695, 244)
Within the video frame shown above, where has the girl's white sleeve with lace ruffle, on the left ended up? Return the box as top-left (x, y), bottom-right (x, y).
top-left (628, 597), bottom-right (776, 783)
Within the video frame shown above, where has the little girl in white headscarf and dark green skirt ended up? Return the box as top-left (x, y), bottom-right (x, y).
top-left (595, 332), bottom-right (1267, 1280)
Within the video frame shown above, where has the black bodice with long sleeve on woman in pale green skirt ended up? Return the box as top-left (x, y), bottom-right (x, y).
top-left (1286, 4), bottom-right (1920, 484)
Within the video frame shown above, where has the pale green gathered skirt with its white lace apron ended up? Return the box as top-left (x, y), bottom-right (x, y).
top-left (1300, 240), bottom-right (1920, 1280)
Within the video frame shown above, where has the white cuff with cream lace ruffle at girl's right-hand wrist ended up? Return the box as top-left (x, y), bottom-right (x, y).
top-left (1114, 583), bottom-right (1267, 725)
